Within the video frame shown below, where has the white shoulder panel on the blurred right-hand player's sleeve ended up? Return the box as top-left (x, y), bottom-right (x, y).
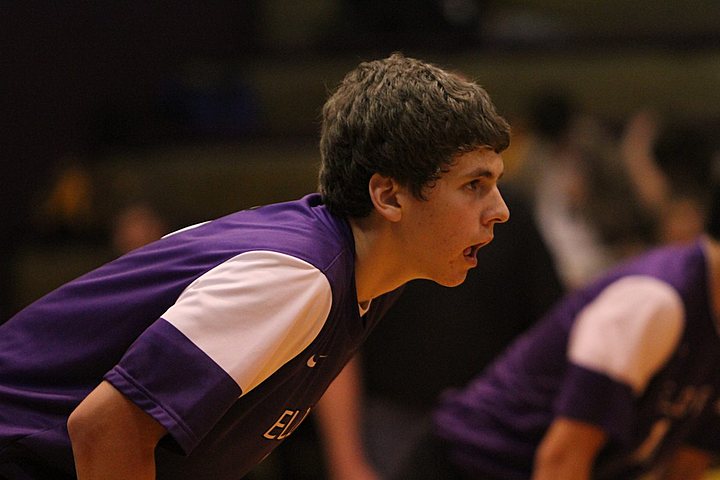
top-left (568, 276), bottom-right (685, 394)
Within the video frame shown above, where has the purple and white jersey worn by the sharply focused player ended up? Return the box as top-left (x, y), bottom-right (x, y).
top-left (0, 194), bottom-right (400, 479)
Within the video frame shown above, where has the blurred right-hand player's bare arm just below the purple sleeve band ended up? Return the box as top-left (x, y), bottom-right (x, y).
top-left (532, 417), bottom-right (607, 480)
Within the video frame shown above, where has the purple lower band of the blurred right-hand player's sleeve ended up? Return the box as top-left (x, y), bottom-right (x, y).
top-left (555, 364), bottom-right (635, 443)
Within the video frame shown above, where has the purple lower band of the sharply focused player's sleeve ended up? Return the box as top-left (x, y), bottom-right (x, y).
top-left (105, 319), bottom-right (242, 454)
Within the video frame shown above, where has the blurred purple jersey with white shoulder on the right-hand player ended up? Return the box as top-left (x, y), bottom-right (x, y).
top-left (434, 241), bottom-right (720, 480)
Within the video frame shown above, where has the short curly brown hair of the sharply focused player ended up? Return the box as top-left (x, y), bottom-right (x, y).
top-left (319, 53), bottom-right (510, 218)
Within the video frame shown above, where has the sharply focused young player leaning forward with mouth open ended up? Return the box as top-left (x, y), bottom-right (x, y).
top-left (0, 54), bottom-right (509, 480)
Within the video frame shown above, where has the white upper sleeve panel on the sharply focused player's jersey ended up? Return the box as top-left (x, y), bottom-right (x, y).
top-left (162, 251), bottom-right (332, 395)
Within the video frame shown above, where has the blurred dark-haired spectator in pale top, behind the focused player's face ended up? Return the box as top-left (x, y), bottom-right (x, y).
top-left (514, 90), bottom-right (650, 289)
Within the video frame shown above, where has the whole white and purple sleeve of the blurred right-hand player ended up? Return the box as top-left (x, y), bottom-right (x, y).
top-left (554, 276), bottom-right (684, 442)
